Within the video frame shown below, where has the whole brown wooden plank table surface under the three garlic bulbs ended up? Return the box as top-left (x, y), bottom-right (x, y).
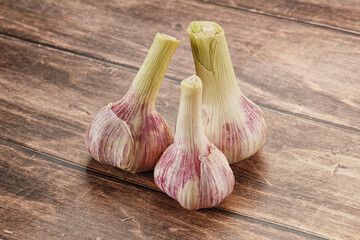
top-left (0, 0), bottom-right (360, 240)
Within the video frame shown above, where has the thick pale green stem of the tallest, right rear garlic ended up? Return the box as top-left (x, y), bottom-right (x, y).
top-left (187, 21), bottom-right (241, 107)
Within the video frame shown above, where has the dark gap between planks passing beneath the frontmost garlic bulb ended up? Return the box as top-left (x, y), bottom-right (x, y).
top-left (0, 137), bottom-right (329, 240)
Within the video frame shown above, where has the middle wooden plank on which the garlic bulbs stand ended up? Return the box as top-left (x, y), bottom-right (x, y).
top-left (0, 35), bottom-right (360, 238)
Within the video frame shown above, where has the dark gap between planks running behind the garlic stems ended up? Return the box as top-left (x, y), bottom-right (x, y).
top-left (0, 32), bottom-right (360, 134)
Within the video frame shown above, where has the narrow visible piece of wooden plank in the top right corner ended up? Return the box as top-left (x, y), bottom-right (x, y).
top-left (205, 0), bottom-right (360, 34)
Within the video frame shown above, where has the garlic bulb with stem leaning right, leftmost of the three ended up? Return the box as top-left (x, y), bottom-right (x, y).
top-left (85, 33), bottom-right (180, 172)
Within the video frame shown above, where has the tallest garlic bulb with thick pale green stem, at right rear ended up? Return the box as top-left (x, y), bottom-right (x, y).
top-left (187, 21), bottom-right (267, 164)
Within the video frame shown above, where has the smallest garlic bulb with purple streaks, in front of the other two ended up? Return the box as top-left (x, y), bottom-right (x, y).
top-left (154, 75), bottom-right (235, 210)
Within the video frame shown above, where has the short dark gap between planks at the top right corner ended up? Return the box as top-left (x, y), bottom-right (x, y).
top-left (200, 0), bottom-right (360, 37)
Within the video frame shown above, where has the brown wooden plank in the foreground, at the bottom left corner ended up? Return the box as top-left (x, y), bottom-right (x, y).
top-left (0, 140), bottom-right (319, 240)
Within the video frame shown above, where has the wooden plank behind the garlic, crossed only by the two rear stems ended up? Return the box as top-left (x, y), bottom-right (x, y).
top-left (0, 0), bottom-right (360, 132)
